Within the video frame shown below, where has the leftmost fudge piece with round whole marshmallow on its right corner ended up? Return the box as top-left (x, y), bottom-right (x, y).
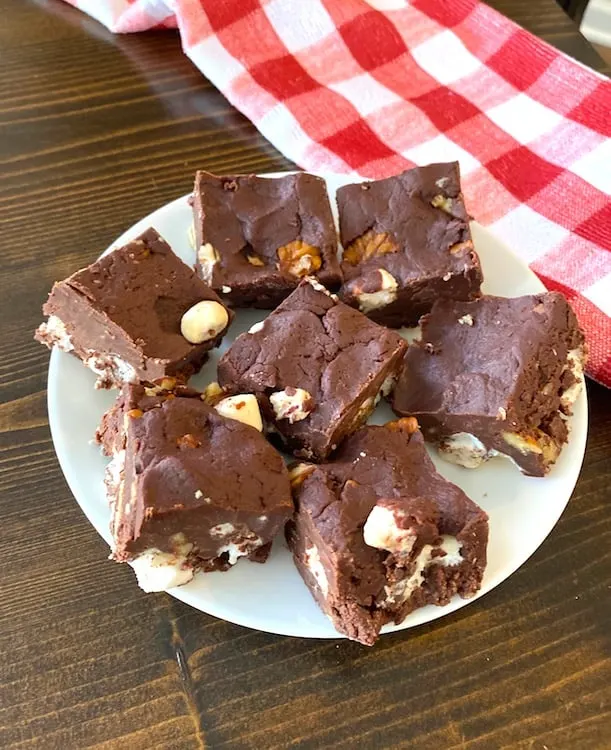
top-left (36, 229), bottom-right (233, 388)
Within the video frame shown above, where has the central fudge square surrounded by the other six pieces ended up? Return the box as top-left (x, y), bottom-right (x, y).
top-left (218, 280), bottom-right (407, 461)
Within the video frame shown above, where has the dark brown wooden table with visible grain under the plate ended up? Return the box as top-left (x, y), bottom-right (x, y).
top-left (0, 0), bottom-right (611, 750)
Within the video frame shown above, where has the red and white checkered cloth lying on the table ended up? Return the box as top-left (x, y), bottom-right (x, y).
top-left (68, 0), bottom-right (611, 386)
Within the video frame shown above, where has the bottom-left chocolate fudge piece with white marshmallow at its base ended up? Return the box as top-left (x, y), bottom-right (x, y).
top-left (96, 379), bottom-right (293, 591)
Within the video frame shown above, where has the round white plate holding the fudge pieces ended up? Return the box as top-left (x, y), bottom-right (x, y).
top-left (48, 176), bottom-right (587, 638)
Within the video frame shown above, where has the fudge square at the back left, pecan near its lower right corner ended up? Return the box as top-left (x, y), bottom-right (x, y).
top-left (193, 172), bottom-right (341, 308)
